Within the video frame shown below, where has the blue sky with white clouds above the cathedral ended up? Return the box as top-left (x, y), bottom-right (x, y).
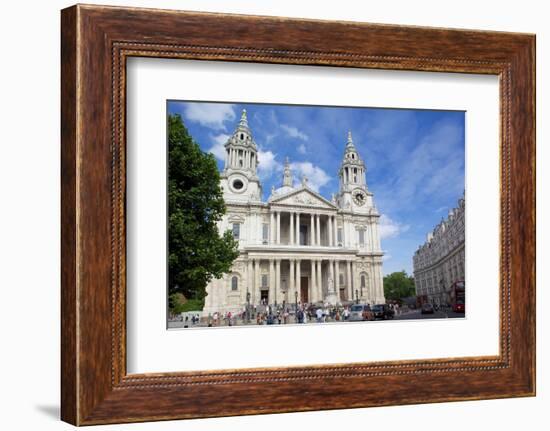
top-left (168, 101), bottom-right (465, 274)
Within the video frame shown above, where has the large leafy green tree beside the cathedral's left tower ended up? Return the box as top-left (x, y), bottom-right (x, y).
top-left (168, 114), bottom-right (239, 304)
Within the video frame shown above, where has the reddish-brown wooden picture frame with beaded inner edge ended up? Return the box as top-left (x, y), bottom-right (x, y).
top-left (61, 5), bottom-right (535, 425)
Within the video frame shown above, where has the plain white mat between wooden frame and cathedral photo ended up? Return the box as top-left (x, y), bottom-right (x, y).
top-left (127, 58), bottom-right (500, 374)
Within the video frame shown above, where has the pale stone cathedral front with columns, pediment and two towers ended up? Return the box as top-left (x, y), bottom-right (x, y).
top-left (203, 111), bottom-right (385, 315)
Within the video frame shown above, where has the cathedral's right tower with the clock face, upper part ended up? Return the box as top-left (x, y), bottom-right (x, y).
top-left (337, 132), bottom-right (373, 214)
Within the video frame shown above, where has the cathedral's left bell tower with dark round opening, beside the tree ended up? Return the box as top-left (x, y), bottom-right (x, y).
top-left (220, 109), bottom-right (262, 202)
